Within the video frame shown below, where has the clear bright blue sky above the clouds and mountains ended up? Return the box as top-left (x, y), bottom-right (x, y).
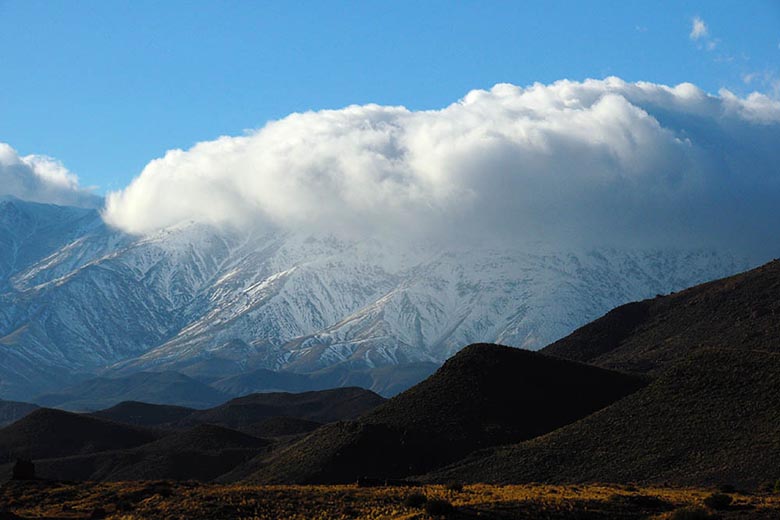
top-left (0, 0), bottom-right (780, 193)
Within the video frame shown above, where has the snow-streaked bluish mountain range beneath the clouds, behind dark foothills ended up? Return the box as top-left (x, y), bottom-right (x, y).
top-left (0, 198), bottom-right (747, 398)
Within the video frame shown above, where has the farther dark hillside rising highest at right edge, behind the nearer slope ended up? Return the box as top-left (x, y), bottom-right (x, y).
top-left (542, 260), bottom-right (780, 374)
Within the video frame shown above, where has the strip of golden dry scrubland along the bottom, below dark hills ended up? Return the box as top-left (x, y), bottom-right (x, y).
top-left (0, 482), bottom-right (780, 520)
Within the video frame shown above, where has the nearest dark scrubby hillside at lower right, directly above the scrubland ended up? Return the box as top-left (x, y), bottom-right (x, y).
top-left (426, 349), bottom-right (780, 488)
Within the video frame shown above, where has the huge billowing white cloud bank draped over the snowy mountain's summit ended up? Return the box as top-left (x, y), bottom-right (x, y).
top-left (104, 78), bottom-right (780, 258)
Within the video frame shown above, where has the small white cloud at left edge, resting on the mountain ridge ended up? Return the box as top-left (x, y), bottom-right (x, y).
top-left (0, 143), bottom-right (102, 208)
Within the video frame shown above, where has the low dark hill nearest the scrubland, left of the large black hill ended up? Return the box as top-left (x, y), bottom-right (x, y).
top-left (36, 424), bottom-right (270, 481)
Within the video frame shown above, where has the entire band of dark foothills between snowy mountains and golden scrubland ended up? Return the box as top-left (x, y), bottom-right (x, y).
top-left (0, 260), bottom-right (780, 490)
